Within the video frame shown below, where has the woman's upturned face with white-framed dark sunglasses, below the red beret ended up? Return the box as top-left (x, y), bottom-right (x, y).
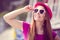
top-left (33, 6), bottom-right (46, 21)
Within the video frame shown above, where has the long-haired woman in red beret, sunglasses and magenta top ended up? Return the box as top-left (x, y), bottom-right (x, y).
top-left (3, 2), bottom-right (60, 40)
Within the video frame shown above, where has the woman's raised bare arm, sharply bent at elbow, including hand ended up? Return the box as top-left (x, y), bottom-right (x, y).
top-left (3, 5), bottom-right (33, 30)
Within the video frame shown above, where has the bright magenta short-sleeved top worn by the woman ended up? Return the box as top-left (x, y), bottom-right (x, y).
top-left (23, 22), bottom-right (56, 40)
